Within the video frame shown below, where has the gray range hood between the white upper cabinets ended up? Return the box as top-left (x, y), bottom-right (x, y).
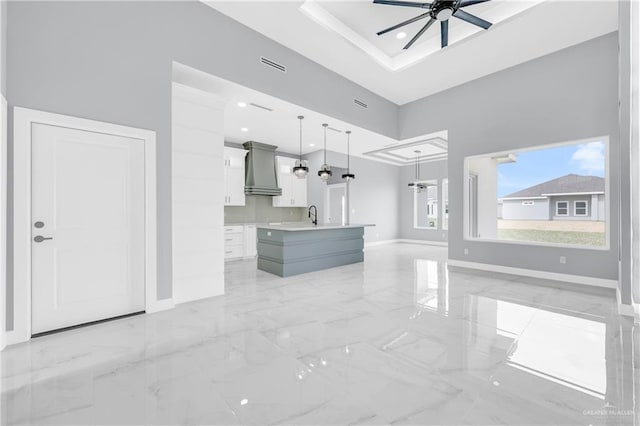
top-left (242, 141), bottom-right (282, 195)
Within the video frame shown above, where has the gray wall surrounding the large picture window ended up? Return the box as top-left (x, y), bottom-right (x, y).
top-left (399, 33), bottom-right (621, 280)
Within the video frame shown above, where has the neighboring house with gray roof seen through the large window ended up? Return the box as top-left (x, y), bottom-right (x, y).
top-left (498, 174), bottom-right (605, 220)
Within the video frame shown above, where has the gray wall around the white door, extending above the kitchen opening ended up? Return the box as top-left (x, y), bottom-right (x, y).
top-left (7, 1), bottom-right (397, 329)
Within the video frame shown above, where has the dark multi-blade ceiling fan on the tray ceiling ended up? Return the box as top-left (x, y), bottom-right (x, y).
top-left (373, 0), bottom-right (492, 49)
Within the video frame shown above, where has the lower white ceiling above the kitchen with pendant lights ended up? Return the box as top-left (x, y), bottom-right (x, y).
top-left (173, 62), bottom-right (447, 165)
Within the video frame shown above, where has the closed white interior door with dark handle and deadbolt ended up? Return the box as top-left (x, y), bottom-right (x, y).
top-left (31, 124), bottom-right (145, 334)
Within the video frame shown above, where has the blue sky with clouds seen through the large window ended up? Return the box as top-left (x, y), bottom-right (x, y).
top-left (498, 142), bottom-right (605, 197)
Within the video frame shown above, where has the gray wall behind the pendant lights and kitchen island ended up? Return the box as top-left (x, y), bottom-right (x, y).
top-left (304, 151), bottom-right (400, 243)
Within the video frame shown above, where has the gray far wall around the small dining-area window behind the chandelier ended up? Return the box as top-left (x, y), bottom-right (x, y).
top-left (398, 160), bottom-right (444, 242)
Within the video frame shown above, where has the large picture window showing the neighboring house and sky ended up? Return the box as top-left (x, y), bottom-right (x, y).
top-left (463, 137), bottom-right (609, 249)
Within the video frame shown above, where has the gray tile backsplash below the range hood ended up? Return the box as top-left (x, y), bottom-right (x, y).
top-left (224, 195), bottom-right (308, 224)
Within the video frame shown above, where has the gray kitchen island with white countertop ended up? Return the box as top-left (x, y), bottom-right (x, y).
top-left (257, 223), bottom-right (374, 277)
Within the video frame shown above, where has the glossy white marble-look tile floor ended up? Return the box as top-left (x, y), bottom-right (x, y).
top-left (0, 244), bottom-right (640, 425)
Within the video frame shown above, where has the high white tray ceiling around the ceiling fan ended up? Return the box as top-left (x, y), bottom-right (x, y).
top-left (205, 0), bottom-right (618, 105)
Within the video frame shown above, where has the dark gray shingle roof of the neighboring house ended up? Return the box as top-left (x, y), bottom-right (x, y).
top-left (503, 173), bottom-right (604, 198)
